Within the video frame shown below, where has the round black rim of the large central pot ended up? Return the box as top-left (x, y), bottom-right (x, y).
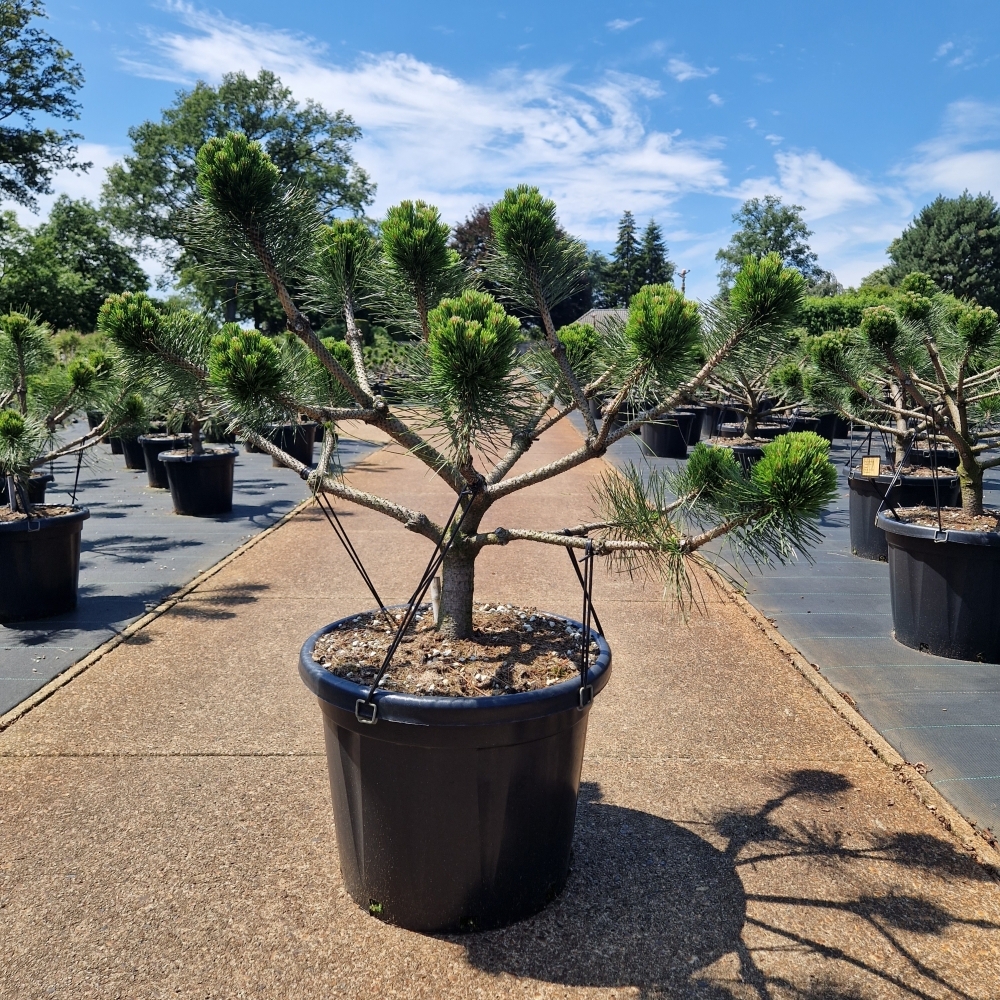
top-left (299, 605), bottom-right (611, 726)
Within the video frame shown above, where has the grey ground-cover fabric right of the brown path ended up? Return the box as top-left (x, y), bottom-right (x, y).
top-left (596, 425), bottom-right (1000, 837)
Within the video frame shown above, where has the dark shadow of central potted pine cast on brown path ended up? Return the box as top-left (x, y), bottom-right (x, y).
top-left (454, 770), bottom-right (1000, 1000)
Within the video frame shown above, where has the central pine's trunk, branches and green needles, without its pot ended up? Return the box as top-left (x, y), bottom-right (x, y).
top-left (102, 134), bottom-right (833, 637)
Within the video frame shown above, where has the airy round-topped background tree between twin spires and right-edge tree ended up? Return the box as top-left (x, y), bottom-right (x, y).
top-left (715, 194), bottom-right (830, 290)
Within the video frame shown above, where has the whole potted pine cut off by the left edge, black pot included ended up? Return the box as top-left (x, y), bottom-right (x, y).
top-left (0, 312), bottom-right (140, 622)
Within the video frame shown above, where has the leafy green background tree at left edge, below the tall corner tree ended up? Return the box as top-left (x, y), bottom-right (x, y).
top-left (0, 195), bottom-right (148, 333)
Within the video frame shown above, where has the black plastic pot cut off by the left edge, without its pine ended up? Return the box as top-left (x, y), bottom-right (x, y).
top-left (0, 508), bottom-right (90, 622)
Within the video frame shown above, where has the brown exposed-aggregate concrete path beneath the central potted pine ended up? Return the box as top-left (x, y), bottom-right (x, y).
top-left (0, 425), bottom-right (1000, 1000)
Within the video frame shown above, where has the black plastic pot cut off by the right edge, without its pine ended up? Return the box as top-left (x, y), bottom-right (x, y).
top-left (878, 513), bottom-right (1000, 663)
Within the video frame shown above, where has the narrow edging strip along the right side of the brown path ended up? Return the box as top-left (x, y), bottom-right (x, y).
top-left (718, 577), bottom-right (1000, 882)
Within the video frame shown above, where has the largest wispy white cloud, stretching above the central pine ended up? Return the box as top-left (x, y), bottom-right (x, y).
top-left (129, 3), bottom-right (728, 240)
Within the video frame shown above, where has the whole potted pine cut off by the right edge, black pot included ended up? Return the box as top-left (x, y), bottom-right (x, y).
top-left (816, 274), bottom-right (1000, 663)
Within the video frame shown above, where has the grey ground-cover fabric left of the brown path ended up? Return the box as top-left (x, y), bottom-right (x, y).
top-left (0, 425), bottom-right (376, 715)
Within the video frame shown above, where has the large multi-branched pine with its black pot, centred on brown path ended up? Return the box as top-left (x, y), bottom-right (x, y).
top-left (113, 134), bottom-right (835, 931)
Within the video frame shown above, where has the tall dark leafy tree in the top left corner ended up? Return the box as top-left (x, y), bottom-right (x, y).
top-left (0, 0), bottom-right (90, 208)
